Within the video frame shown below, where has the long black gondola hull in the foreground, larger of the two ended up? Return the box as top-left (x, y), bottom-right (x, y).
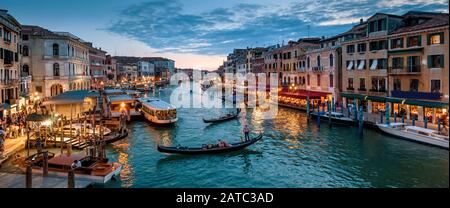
top-left (158, 134), bottom-right (262, 155)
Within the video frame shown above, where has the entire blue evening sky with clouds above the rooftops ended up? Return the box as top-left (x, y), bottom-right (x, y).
top-left (0, 0), bottom-right (448, 69)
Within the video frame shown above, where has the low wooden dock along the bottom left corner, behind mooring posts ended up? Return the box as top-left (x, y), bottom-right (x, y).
top-left (0, 173), bottom-right (92, 188)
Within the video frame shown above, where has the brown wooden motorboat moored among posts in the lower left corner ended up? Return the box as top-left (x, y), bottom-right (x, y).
top-left (21, 152), bottom-right (122, 184)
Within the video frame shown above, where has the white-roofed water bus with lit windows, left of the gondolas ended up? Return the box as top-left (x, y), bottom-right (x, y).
top-left (139, 98), bottom-right (178, 124)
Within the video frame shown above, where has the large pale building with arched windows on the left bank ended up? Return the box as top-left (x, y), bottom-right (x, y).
top-left (22, 25), bottom-right (91, 98)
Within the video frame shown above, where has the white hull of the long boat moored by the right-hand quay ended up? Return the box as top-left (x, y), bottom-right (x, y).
top-left (377, 124), bottom-right (449, 149)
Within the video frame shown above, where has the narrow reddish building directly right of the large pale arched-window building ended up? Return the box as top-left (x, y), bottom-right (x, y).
top-left (86, 43), bottom-right (108, 89)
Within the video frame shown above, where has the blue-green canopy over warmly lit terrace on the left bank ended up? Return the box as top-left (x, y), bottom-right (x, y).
top-left (43, 90), bottom-right (100, 117)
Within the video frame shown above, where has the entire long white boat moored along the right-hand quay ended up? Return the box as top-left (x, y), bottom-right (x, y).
top-left (377, 123), bottom-right (448, 149)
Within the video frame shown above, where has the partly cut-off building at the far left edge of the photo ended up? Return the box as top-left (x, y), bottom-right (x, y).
top-left (0, 10), bottom-right (22, 118)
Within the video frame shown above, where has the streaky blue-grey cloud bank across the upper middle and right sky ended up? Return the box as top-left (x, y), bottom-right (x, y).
top-left (107, 0), bottom-right (448, 55)
